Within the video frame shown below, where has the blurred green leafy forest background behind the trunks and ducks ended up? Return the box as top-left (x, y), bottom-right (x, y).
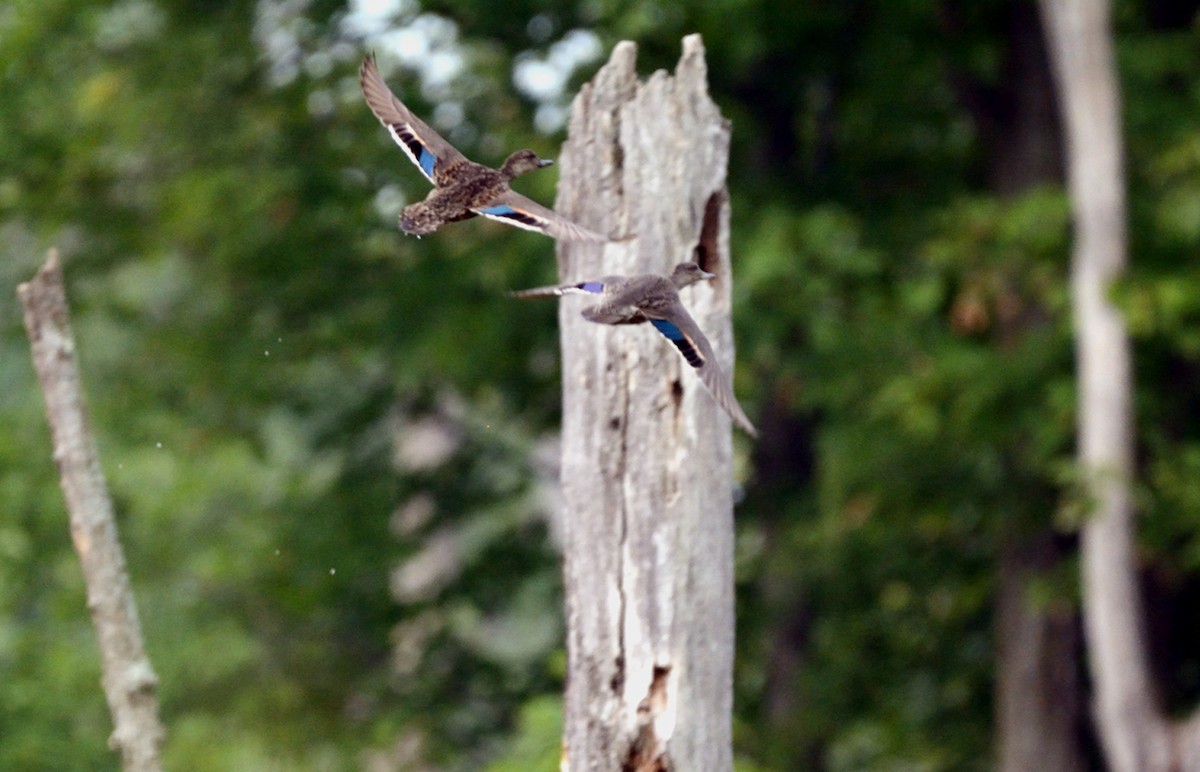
top-left (0, 0), bottom-right (1200, 771)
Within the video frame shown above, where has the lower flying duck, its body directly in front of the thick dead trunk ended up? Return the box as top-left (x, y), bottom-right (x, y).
top-left (511, 262), bottom-right (758, 437)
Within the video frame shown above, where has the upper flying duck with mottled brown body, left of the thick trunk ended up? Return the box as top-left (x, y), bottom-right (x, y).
top-left (359, 55), bottom-right (610, 241)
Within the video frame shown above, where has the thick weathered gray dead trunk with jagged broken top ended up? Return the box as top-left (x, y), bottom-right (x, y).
top-left (557, 35), bottom-right (733, 772)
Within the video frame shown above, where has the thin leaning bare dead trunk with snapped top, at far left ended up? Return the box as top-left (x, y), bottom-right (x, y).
top-left (17, 250), bottom-right (163, 772)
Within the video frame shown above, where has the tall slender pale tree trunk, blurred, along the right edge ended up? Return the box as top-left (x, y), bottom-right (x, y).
top-left (1040, 0), bottom-right (1200, 772)
